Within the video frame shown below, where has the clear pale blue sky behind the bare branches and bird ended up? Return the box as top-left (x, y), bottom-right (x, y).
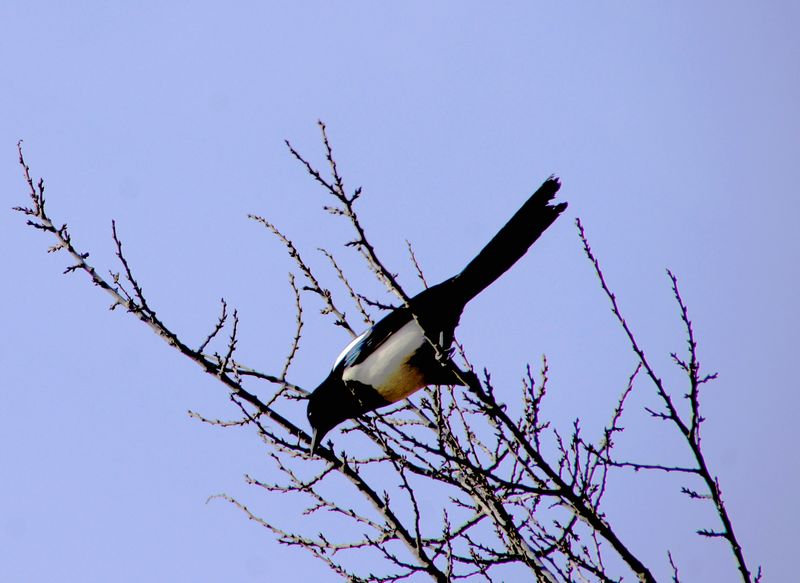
top-left (0, 1), bottom-right (800, 582)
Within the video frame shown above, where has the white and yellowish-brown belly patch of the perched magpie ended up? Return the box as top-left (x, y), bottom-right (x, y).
top-left (342, 320), bottom-right (426, 403)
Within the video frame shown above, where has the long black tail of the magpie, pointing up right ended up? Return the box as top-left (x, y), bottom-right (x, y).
top-left (451, 177), bottom-right (567, 304)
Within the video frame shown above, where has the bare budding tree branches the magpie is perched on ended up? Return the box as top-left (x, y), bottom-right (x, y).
top-left (15, 123), bottom-right (761, 583)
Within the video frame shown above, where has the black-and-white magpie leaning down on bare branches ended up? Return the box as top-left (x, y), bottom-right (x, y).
top-left (307, 176), bottom-right (567, 455)
